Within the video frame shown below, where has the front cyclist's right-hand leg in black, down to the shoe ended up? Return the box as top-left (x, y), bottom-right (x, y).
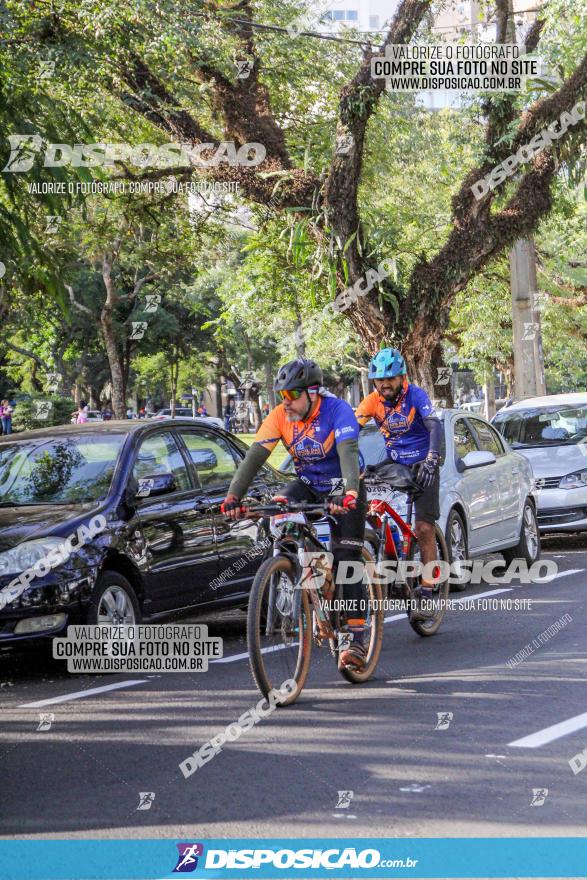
top-left (331, 481), bottom-right (367, 664)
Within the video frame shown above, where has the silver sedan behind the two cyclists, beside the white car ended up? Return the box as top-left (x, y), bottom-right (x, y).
top-left (279, 409), bottom-right (540, 590)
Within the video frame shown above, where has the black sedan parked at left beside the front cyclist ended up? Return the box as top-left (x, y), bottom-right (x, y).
top-left (0, 419), bottom-right (287, 646)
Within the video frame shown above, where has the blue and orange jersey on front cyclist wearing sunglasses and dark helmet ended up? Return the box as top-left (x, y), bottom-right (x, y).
top-left (255, 397), bottom-right (359, 495)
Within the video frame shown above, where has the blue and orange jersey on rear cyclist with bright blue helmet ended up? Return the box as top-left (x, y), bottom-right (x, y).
top-left (355, 380), bottom-right (434, 465)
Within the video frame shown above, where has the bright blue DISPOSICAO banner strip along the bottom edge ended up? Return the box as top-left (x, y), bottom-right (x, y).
top-left (0, 837), bottom-right (587, 880)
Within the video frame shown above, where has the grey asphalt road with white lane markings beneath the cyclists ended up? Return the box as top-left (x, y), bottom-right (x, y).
top-left (0, 537), bottom-right (587, 840)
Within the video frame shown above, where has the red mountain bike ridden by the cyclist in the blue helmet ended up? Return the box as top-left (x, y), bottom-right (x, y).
top-left (364, 461), bottom-right (450, 636)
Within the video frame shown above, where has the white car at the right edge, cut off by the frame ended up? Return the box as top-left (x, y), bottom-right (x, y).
top-left (492, 393), bottom-right (587, 532)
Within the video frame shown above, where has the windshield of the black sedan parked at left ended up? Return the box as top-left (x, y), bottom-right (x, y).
top-left (0, 434), bottom-right (125, 506)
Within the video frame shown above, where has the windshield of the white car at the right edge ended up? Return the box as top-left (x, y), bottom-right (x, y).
top-left (493, 405), bottom-right (587, 449)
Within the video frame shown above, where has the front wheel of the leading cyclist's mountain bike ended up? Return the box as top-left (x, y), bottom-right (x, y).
top-left (247, 556), bottom-right (312, 706)
